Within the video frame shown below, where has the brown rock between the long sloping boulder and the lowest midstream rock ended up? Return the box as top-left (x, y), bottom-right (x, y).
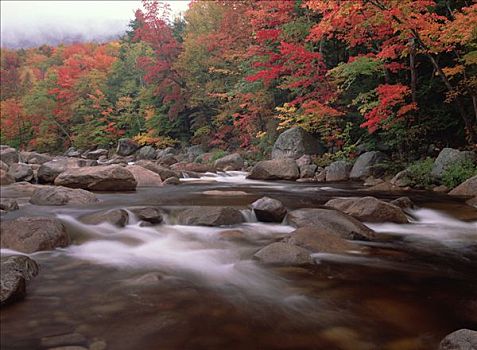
top-left (284, 226), bottom-right (360, 253)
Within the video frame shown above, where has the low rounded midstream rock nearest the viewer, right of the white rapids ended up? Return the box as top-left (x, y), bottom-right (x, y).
top-left (254, 242), bottom-right (313, 266)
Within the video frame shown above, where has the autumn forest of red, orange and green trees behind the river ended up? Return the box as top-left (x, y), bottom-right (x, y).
top-left (0, 0), bottom-right (477, 160)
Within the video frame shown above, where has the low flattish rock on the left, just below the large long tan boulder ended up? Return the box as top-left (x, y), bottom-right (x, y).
top-left (30, 186), bottom-right (99, 205)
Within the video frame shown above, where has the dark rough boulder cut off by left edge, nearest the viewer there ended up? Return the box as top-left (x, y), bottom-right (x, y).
top-left (0, 255), bottom-right (38, 306)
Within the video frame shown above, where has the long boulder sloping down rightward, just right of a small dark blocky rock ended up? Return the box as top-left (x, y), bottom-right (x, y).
top-left (286, 208), bottom-right (376, 240)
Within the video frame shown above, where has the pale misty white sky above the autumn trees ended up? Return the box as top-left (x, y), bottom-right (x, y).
top-left (0, 0), bottom-right (189, 48)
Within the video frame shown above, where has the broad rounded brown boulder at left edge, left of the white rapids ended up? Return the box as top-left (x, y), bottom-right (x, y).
top-left (0, 217), bottom-right (70, 254)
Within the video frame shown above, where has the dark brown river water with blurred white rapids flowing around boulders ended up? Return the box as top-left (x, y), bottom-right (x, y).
top-left (0, 172), bottom-right (477, 350)
